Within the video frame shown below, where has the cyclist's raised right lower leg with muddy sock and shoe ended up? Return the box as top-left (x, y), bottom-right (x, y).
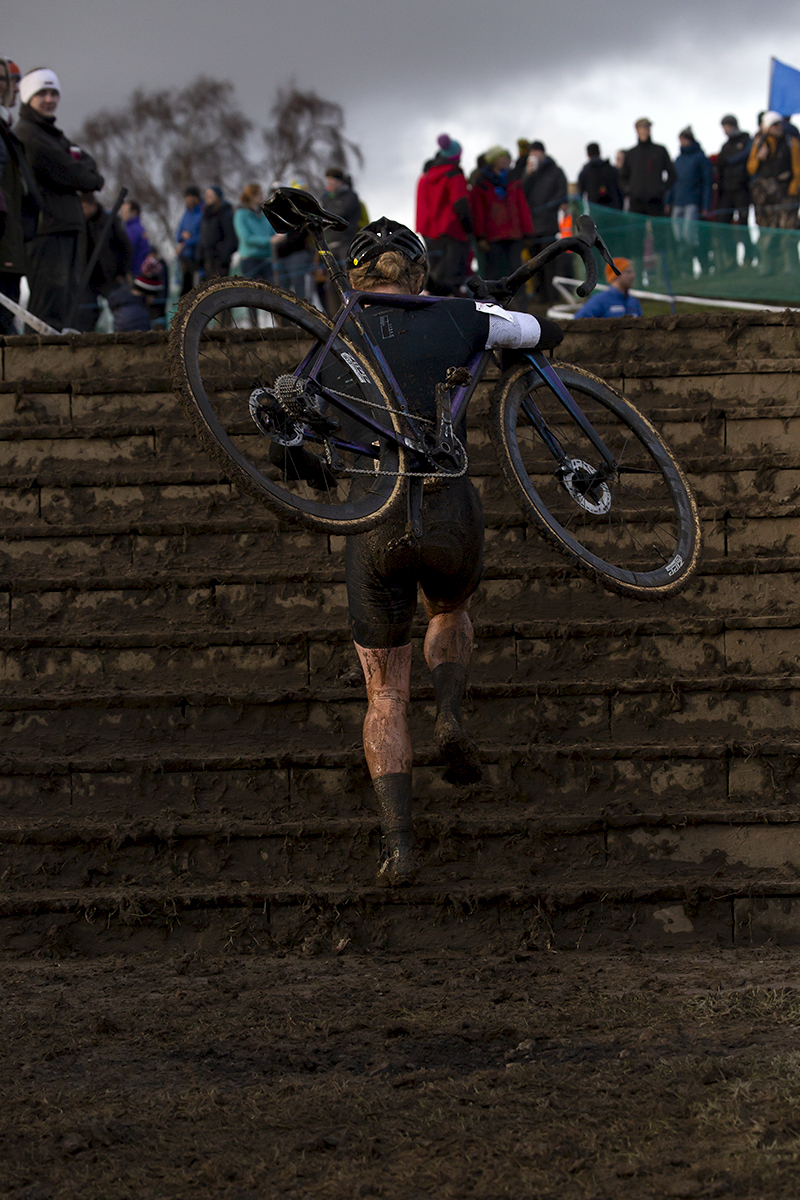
top-left (425, 599), bottom-right (482, 784)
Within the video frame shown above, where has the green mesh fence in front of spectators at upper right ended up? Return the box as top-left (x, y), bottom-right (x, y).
top-left (578, 204), bottom-right (800, 305)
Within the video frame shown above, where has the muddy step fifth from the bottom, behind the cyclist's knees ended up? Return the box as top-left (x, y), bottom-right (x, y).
top-left (0, 619), bottom-right (748, 701)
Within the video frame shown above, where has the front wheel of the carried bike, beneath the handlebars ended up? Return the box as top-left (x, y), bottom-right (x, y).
top-left (489, 364), bottom-right (700, 600)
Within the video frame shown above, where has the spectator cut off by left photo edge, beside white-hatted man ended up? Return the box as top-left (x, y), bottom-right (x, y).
top-left (0, 59), bottom-right (38, 336)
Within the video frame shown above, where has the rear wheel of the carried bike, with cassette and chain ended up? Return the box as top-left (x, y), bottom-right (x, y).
top-left (169, 278), bottom-right (404, 534)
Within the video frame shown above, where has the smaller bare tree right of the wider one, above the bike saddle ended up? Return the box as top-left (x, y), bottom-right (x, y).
top-left (264, 83), bottom-right (363, 191)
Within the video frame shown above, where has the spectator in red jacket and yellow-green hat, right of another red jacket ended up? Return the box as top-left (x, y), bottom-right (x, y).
top-left (469, 146), bottom-right (534, 295)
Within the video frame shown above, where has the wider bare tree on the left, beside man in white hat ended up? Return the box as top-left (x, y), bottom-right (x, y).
top-left (77, 76), bottom-right (257, 242)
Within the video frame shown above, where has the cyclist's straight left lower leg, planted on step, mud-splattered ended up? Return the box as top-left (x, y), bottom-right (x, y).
top-left (356, 643), bottom-right (417, 884)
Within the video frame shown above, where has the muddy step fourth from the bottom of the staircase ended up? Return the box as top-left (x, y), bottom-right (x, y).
top-left (0, 676), bottom-right (800, 769)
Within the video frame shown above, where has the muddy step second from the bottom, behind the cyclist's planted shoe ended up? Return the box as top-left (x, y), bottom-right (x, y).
top-left (0, 808), bottom-right (800, 896)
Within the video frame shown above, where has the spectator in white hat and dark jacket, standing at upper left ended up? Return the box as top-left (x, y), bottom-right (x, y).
top-left (14, 67), bottom-right (103, 329)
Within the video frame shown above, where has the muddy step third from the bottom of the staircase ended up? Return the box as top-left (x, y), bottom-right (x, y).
top-left (0, 731), bottom-right (800, 824)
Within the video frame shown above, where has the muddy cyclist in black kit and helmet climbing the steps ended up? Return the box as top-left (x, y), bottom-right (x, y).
top-left (345, 217), bottom-right (564, 884)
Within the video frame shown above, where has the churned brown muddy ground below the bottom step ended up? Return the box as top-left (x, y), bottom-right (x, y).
top-left (0, 948), bottom-right (800, 1200)
